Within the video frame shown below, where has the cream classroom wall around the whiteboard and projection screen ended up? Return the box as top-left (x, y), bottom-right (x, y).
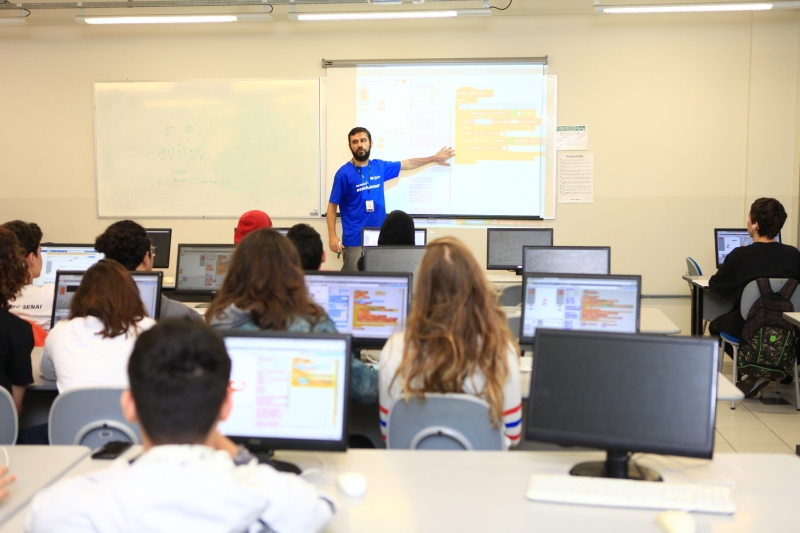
top-left (0, 11), bottom-right (800, 294)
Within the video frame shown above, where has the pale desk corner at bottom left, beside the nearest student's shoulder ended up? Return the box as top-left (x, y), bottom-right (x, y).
top-left (0, 446), bottom-right (90, 531)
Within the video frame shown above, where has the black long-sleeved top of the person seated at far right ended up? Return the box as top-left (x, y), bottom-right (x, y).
top-left (708, 242), bottom-right (800, 309)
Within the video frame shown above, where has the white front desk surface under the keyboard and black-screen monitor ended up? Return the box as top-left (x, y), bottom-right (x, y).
top-left (6, 444), bottom-right (800, 533)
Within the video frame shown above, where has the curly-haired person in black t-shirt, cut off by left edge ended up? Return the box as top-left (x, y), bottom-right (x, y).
top-left (0, 228), bottom-right (33, 412)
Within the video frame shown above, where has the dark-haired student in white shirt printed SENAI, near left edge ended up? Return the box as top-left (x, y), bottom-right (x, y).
top-left (3, 220), bottom-right (55, 334)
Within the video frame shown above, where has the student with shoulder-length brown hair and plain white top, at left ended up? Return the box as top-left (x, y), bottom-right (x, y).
top-left (39, 259), bottom-right (156, 392)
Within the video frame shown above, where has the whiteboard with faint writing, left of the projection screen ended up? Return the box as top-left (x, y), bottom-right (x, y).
top-left (94, 78), bottom-right (321, 218)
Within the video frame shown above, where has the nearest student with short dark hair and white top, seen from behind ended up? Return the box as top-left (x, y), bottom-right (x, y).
top-left (25, 320), bottom-right (333, 533)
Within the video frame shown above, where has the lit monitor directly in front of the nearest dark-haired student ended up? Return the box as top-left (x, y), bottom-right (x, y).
top-left (217, 331), bottom-right (352, 451)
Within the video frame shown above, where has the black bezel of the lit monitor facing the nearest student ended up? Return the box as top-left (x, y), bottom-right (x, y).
top-left (220, 329), bottom-right (352, 452)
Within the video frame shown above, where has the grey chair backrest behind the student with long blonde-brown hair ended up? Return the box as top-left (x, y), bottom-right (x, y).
top-left (386, 394), bottom-right (505, 450)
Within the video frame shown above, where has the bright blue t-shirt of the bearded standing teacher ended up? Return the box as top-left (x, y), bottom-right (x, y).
top-left (329, 159), bottom-right (400, 246)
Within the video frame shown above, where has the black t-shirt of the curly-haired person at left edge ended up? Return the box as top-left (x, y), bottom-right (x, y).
top-left (0, 309), bottom-right (33, 392)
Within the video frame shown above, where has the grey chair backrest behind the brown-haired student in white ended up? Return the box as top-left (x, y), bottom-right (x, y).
top-left (48, 388), bottom-right (142, 450)
